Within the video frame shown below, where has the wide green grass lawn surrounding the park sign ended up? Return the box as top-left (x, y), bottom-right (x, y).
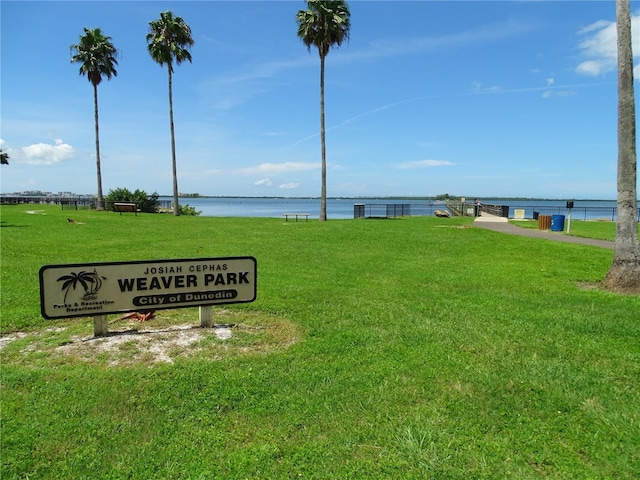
top-left (0, 205), bottom-right (640, 480)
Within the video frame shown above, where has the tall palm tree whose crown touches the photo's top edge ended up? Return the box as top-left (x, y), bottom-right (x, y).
top-left (296, 0), bottom-right (351, 221)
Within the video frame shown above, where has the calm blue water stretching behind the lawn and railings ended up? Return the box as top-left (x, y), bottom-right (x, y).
top-left (160, 197), bottom-right (616, 219)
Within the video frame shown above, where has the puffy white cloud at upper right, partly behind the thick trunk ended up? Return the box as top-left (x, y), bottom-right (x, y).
top-left (576, 15), bottom-right (640, 76)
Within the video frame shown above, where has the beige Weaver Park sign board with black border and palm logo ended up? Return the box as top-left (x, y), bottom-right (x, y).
top-left (40, 257), bottom-right (257, 319)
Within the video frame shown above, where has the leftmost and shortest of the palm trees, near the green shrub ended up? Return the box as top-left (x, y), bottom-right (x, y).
top-left (70, 28), bottom-right (118, 210)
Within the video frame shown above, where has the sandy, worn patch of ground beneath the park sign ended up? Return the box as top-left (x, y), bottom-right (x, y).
top-left (0, 310), bottom-right (299, 367)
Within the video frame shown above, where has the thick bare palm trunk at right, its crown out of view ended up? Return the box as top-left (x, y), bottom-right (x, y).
top-left (604, 0), bottom-right (640, 294)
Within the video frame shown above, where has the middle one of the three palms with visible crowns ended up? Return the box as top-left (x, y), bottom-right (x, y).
top-left (147, 10), bottom-right (194, 216)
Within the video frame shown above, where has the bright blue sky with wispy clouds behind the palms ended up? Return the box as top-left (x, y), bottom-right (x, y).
top-left (0, 0), bottom-right (640, 199)
